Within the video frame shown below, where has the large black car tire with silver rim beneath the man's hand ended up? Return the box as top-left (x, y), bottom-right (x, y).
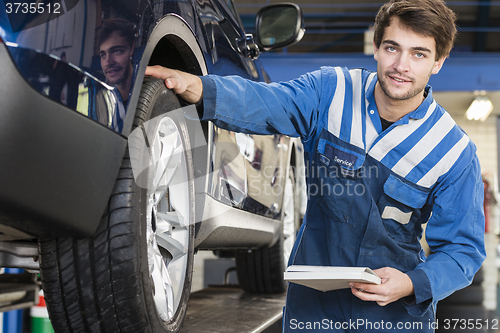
top-left (39, 78), bottom-right (195, 333)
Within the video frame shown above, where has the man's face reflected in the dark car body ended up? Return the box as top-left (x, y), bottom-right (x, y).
top-left (99, 31), bottom-right (134, 85)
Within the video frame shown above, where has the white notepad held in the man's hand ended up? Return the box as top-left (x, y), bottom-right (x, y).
top-left (285, 265), bottom-right (381, 291)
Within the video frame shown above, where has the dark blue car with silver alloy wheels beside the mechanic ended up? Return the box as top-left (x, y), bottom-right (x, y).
top-left (0, 0), bottom-right (304, 333)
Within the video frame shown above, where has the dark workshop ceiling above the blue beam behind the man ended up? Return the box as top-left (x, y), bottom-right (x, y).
top-left (236, 0), bottom-right (500, 53)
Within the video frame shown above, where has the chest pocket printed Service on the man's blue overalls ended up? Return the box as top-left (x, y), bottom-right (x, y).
top-left (318, 139), bottom-right (365, 223)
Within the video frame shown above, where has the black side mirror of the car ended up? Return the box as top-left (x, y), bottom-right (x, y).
top-left (255, 3), bottom-right (305, 51)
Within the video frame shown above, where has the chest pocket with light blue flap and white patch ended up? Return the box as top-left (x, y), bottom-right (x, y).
top-left (378, 175), bottom-right (429, 243)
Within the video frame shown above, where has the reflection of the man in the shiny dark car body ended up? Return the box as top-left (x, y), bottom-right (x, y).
top-left (98, 18), bottom-right (135, 132)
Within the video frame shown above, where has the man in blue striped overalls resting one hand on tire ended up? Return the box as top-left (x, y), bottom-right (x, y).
top-left (146, 0), bottom-right (485, 332)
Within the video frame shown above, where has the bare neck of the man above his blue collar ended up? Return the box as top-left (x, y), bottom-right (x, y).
top-left (374, 82), bottom-right (424, 122)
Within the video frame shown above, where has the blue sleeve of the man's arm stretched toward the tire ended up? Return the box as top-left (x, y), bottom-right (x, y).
top-left (201, 70), bottom-right (328, 139)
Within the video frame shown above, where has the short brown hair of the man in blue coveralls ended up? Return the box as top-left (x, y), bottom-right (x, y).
top-left (373, 0), bottom-right (457, 60)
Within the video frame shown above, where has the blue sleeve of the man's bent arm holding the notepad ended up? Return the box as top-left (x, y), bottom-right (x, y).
top-left (415, 144), bottom-right (486, 308)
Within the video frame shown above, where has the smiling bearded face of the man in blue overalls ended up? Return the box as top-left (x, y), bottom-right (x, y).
top-left (374, 17), bottom-right (444, 102)
